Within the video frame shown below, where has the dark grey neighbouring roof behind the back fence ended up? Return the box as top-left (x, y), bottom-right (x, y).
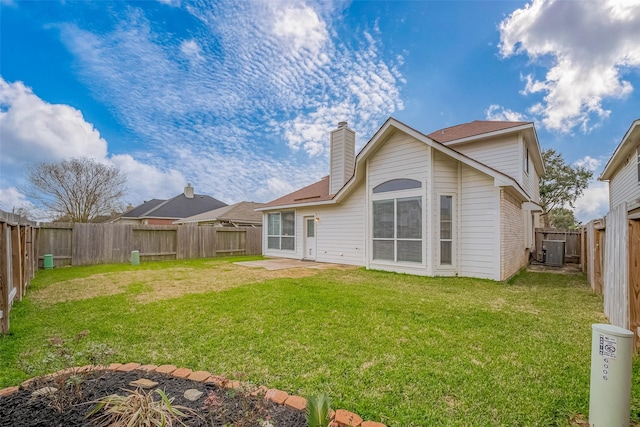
top-left (120, 193), bottom-right (227, 219)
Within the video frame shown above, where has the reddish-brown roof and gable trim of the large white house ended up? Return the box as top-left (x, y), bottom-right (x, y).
top-left (258, 117), bottom-right (533, 211)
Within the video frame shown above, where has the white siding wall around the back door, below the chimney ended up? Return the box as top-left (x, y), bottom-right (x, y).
top-left (296, 183), bottom-right (366, 266)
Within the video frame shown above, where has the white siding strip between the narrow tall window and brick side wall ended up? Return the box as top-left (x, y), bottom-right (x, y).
top-left (458, 166), bottom-right (500, 280)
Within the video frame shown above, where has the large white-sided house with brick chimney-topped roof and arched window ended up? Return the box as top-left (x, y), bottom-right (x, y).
top-left (259, 118), bottom-right (544, 280)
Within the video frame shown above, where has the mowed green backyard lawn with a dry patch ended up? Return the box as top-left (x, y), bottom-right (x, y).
top-left (0, 258), bottom-right (640, 426)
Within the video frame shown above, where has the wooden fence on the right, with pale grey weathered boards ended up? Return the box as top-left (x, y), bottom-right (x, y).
top-left (582, 203), bottom-right (640, 352)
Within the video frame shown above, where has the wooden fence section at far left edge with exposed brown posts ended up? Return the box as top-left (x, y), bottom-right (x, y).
top-left (0, 211), bottom-right (38, 334)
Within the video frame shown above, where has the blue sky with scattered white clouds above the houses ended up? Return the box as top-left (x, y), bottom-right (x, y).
top-left (0, 0), bottom-right (640, 222)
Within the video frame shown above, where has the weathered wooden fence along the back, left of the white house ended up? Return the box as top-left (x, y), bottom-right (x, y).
top-left (39, 223), bottom-right (262, 267)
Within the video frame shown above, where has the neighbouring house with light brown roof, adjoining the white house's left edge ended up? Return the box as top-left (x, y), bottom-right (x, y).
top-left (174, 202), bottom-right (264, 227)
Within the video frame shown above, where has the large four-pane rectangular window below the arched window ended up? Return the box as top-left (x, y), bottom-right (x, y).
top-left (373, 197), bottom-right (422, 263)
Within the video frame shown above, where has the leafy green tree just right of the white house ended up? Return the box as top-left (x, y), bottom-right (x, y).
top-left (540, 149), bottom-right (593, 227)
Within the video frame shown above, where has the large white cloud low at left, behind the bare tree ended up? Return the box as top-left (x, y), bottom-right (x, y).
top-left (0, 77), bottom-right (200, 210)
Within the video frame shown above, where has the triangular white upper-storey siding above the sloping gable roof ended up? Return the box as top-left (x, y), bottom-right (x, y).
top-left (451, 135), bottom-right (520, 185)
